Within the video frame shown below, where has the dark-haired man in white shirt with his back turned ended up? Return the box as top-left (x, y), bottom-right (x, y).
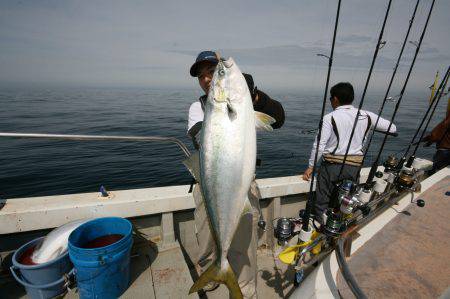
top-left (303, 82), bottom-right (397, 220)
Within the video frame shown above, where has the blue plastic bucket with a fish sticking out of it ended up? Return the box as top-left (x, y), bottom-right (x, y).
top-left (10, 237), bottom-right (73, 299)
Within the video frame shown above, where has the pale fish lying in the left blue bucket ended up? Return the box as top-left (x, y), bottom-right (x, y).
top-left (31, 219), bottom-right (91, 264)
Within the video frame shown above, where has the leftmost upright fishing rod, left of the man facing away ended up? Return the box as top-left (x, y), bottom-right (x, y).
top-left (302, 0), bottom-right (341, 231)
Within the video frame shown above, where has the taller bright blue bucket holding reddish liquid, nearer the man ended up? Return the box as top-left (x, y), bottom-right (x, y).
top-left (69, 217), bottom-right (133, 299)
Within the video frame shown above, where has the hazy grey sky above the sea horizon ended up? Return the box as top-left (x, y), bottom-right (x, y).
top-left (0, 0), bottom-right (450, 89)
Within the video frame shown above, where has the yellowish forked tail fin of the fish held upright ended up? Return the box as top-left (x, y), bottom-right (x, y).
top-left (189, 261), bottom-right (243, 299)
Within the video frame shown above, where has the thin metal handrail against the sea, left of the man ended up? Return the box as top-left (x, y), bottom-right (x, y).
top-left (0, 132), bottom-right (191, 157)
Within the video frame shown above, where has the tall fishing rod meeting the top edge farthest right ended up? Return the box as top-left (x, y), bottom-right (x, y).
top-left (366, 0), bottom-right (435, 186)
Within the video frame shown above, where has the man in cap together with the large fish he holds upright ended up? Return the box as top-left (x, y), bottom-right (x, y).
top-left (188, 51), bottom-right (284, 298)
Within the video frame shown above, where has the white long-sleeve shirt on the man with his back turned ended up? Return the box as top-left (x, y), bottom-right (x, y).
top-left (309, 105), bottom-right (397, 167)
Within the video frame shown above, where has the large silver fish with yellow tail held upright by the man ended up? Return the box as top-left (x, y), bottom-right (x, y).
top-left (189, 58), bottom-right (275, 298)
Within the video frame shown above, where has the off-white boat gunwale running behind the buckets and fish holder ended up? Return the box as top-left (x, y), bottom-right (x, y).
top-left (0, 168), bottom-right (418, 254)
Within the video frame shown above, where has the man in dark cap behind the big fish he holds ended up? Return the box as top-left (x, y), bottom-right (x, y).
top-left (188, 51), bottom-right (284, 298)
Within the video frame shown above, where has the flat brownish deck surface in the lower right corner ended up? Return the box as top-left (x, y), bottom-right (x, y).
top-left (337, 172), bottom-right (450, 298)
